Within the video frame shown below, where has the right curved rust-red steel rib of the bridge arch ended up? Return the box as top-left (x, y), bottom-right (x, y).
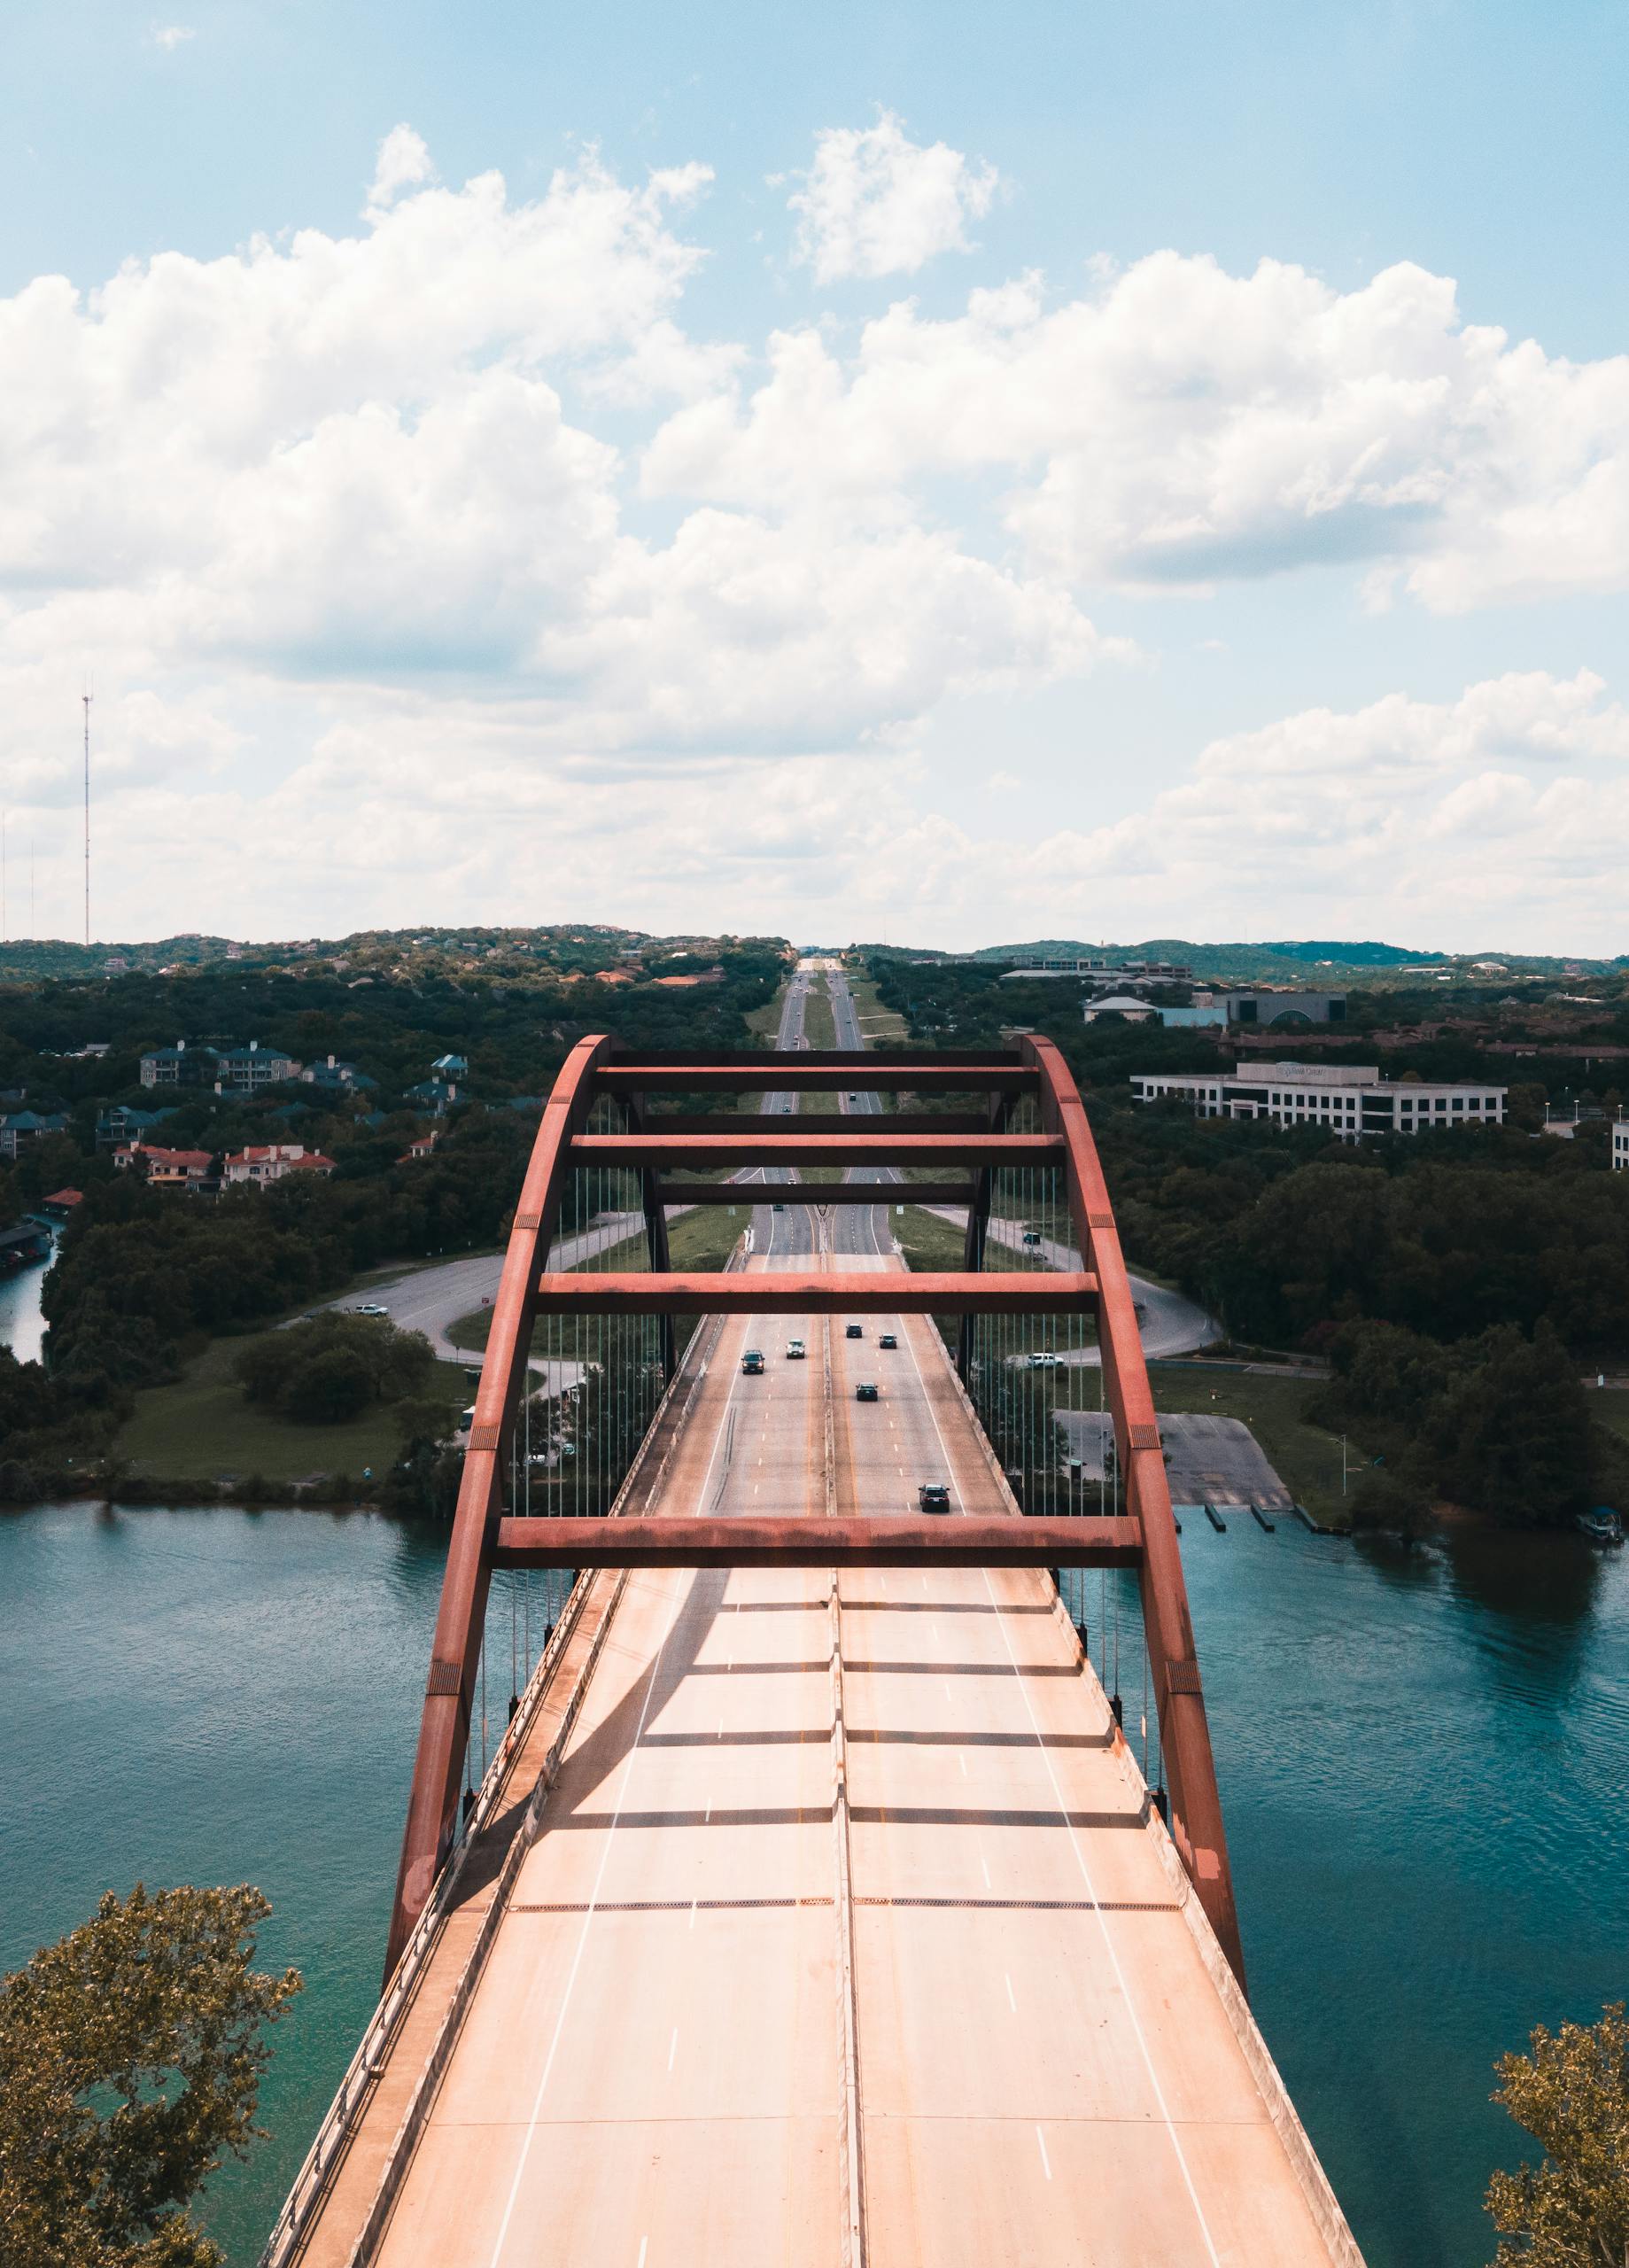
top-left (1019, 1034), bottom-right (1245, 1987)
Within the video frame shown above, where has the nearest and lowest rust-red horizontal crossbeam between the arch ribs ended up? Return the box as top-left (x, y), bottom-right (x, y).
top-left (497, 1513), bottom-right (1141, 1567)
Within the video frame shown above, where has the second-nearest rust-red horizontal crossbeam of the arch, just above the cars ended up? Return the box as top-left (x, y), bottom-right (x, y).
top-left (538, 1268), bottom-right (1098, 1316)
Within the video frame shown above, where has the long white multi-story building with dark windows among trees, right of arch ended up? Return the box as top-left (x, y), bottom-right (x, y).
top-left (1132, 1064), bottom-right (1507, 1141)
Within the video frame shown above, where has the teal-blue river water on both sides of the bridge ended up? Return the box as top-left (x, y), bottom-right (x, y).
top-left (0, 1506), bottom-right (1629, 2268)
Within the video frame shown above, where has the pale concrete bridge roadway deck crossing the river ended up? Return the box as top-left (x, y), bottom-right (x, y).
top-left (287, 1256), bottom-right (1357, 2268)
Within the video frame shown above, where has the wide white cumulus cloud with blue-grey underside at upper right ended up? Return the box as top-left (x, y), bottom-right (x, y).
top-left (644, 252), bottom-right (1629, 612)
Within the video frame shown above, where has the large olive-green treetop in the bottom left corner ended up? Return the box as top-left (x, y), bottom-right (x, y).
top-left (0, 1883), bottom-right (302, 2268)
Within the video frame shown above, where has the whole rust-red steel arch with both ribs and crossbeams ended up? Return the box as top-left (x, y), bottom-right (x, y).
top-left (385, 1037), bottom-right (1244, 1984)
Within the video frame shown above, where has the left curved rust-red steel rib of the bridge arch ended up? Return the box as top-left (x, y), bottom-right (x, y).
top-left (385, 1037), bottom-right (610, 1982)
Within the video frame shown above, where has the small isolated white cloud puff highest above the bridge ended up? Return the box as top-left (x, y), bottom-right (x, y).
top-left (787, 111), bottom-right (998, 284)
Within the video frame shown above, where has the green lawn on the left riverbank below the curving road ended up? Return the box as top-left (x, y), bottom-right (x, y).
top-left (109, 1338), bottom-right (469, 1481)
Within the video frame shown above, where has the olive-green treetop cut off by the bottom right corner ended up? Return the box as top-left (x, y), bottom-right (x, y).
top-left (1486, 2000), bottom-right (1629, 2268)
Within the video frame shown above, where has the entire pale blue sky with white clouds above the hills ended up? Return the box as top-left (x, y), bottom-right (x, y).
top-left (0, 0), bottom-right (1629, 951)
